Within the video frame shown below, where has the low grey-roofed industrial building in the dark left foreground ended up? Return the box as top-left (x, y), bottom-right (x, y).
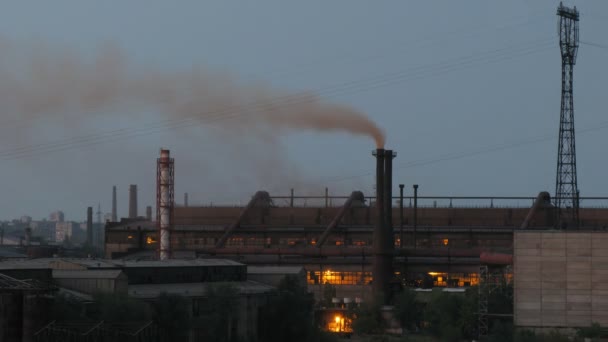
top-left (0, 258), bottom-right (276, 340)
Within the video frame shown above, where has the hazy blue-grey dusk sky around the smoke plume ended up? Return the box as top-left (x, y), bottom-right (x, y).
top-left (0, 0), bottom-right (608, 221)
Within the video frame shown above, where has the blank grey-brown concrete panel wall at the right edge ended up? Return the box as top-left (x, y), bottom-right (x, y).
top-left (514, 231), bottom-right (608, 328)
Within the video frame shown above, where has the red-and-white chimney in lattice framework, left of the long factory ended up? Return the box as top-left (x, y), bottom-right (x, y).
top-left (156, 149), bottom-right (175, 260)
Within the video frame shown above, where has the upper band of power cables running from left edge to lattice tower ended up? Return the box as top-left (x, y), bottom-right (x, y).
top-left (0, 39), bottom-right (553, 160)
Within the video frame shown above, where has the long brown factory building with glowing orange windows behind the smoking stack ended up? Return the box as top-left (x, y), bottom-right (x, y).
top-left (105, 190), bottom-right (608, 298)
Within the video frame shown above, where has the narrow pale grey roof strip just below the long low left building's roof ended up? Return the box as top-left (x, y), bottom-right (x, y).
top-left (129, 280), bottom-right (274, 299)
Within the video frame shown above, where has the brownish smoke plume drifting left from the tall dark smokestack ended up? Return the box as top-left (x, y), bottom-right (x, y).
top-left (0, 40), bottom-right (384, 147)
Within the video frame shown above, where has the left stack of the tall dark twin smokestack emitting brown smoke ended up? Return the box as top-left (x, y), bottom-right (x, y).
top-left (372, 148), bottom-right (392, 304)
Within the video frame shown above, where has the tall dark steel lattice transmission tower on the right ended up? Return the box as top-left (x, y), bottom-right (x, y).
top-left (555, 3), bottom-right (579, 227)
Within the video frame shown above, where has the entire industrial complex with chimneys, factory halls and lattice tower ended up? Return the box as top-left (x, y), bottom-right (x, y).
top-left (0, 4), bottom-right (608, 342)
